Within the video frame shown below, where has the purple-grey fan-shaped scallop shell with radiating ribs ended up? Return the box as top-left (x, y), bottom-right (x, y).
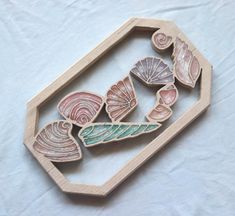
top-left (131, 57), bottom-right (174, 86)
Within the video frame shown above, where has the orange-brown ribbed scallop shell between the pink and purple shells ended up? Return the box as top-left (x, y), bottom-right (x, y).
top-left (106, 76), bottom-right (137, 122)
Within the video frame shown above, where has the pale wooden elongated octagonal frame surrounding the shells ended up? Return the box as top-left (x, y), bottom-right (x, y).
top-left (24, 18), bottom-right (212, 196)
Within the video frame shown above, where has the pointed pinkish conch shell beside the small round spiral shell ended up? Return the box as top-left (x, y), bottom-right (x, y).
top-left (173, 37), bottom-right (201, 88)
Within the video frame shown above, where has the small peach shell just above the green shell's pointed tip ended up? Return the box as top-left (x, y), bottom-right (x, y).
top-left (146, 103), bottom-right (172, 122)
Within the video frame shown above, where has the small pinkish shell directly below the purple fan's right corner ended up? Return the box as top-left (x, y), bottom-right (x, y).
top-left (157, 84), bottom-right (178, 106)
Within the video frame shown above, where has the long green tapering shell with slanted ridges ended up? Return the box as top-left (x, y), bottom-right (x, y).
top-left (78, 122), bottom-right (161, 147)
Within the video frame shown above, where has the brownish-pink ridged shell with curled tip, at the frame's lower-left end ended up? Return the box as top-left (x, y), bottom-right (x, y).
top-left (33, 121), bottom-right (82, 162)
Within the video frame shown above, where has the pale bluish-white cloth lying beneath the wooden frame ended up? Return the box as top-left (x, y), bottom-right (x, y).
top-left (0, 0), bottom-right (235, 216)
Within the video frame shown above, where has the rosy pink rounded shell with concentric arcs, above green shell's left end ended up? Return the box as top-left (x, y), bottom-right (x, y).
top-left (57, 92), bottom-right (104, 127)
